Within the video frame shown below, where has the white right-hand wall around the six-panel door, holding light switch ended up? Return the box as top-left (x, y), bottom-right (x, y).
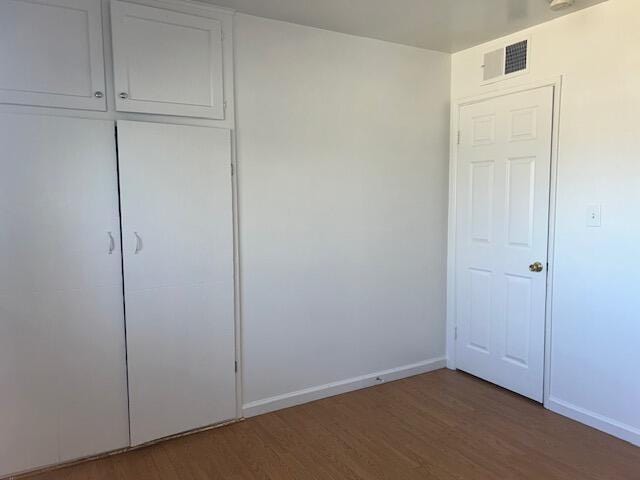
top-left (452, 0), bottom-right (640, 444)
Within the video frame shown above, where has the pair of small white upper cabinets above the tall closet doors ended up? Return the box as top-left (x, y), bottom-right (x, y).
top-left (0, 0), bottom-right (234, 119)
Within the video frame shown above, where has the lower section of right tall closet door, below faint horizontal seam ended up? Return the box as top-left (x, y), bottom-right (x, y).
top-left (126, 282), bottom-right (235, 445)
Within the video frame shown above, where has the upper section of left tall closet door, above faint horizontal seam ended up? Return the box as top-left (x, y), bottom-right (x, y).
top-left (0, 119), bottom-right (122, 291)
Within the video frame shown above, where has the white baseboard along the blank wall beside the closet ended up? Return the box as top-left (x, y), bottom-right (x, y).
top-left (242, 357), bottom-right (447, 418)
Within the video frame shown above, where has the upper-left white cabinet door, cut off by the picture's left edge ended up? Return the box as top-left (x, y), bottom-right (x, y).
top-left (0, 0), bottom-right (106, 110)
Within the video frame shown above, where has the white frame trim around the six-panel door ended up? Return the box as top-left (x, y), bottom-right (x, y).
top-left (446, 76), bottom-right (562, 407)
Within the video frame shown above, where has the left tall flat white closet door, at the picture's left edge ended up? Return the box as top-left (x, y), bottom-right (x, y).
top-left (0, 114), bottom-right (129, 477)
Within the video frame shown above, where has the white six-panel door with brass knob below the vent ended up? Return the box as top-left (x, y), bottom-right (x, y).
top-left (456, 87), bottom-right (553, 401)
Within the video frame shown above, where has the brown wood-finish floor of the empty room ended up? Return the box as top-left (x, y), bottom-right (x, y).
top-left (21, 370), bottom-right (640, 480)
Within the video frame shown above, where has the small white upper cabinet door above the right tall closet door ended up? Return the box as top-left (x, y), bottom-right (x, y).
top-left (111, 0), bottom-right (224, 119)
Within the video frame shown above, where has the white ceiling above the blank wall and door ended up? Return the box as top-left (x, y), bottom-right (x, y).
top-left (204, 0), bottom-right (606, 52)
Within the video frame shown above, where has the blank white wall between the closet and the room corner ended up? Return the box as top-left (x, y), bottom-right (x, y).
top-left (235, 15), bottom-right (450, 415)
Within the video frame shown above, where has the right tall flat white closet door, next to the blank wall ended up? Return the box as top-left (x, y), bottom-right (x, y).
top-left (118, 122), bottom-right (236, 445)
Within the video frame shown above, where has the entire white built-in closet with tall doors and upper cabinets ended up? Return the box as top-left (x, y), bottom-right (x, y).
top-left (0, 0), bottom-right (237, 478)
